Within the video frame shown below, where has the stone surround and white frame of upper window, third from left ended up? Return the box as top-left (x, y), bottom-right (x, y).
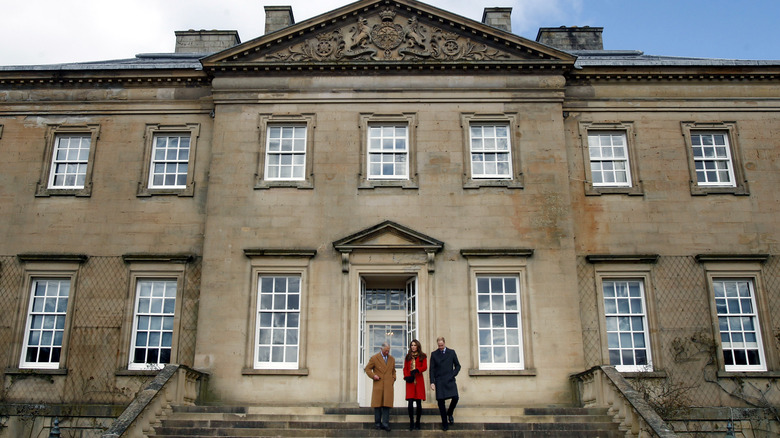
top-left (255, 114), bottom-right (317, 189)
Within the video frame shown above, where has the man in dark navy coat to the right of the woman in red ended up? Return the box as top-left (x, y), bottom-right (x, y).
top-left (428, 337), bottom-right (460, 430)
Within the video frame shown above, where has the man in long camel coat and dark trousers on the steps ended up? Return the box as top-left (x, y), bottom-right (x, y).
top-left (365, 342), bottom-right (395, 432)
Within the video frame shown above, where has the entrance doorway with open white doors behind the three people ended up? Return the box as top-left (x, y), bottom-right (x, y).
top-left (358, 275), bottom-right (418, 407)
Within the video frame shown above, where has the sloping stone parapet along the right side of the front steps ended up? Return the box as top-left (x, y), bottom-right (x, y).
top-left (571, 365), bottom-right (677, 438)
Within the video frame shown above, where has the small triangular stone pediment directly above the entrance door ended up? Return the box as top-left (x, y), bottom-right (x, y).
top-left (333, 221), bottom-right (444, 252)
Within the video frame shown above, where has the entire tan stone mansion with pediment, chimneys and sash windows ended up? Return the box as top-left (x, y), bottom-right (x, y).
top-left (0, 0), bottom-right (780, 436)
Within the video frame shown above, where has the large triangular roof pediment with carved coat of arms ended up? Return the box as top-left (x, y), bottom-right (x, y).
top-left (202, 0), bottom-right (575, 71)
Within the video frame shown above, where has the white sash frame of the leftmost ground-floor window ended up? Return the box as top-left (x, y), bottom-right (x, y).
top-left (19, 276), bottom-right (73, 369)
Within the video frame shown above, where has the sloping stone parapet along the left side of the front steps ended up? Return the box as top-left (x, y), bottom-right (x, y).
top-left (102, 364), bottom-right (208, 438)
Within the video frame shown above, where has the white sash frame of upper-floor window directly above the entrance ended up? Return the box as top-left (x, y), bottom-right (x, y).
top-left (366, 122), bottom-right (409, 180)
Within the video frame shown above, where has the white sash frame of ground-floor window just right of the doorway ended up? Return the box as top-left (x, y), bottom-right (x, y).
top-left (474, 274), bottom-right (525, 370)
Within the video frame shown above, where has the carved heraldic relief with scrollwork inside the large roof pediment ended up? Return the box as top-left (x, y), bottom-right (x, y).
top-left (266, 8), bottom-right (509, 62)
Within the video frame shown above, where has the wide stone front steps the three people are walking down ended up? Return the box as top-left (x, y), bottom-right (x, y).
top-left (149, 406), bottom-right (625, 438)
